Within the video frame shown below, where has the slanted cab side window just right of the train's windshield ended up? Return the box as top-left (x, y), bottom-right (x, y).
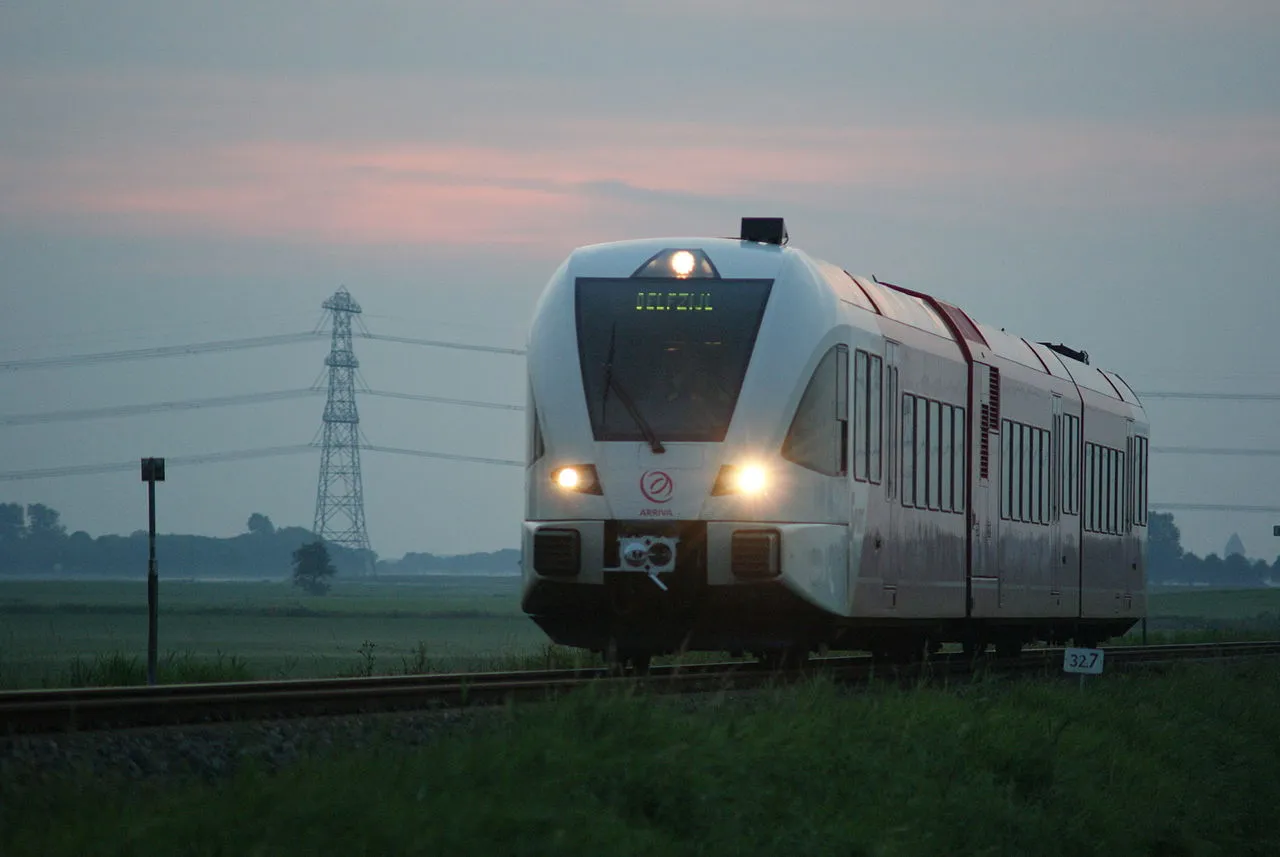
top-left (782, 345), bottom-right (849, 476)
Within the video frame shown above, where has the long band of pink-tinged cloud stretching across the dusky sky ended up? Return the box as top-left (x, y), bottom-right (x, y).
top-left (0, 113), bottom-right (1280, 246)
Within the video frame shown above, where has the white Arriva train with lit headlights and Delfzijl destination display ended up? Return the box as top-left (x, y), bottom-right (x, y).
top-left (522, 217), bottom-right (1148, 666)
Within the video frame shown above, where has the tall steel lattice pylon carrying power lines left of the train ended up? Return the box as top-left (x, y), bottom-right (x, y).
top-left (312, 288), bottom-right (370, 560)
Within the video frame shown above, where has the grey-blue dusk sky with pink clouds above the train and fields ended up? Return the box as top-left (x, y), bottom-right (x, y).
top-left (0, 0), bottom-right (1280, 559)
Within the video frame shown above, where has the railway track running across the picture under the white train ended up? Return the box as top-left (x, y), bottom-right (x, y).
top-left (0, 641), bottom-right (1280, 737)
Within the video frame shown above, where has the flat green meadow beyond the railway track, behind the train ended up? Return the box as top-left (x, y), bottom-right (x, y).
top-left (0, 576), bottom-right (1280, 688)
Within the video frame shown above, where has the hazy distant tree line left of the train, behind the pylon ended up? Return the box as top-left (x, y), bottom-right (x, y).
top-left (0, 503), bottom-right (520, 578)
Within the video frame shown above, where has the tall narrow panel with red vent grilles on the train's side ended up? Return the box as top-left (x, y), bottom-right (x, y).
top-left (969, 362), bottom-right (1001, 617)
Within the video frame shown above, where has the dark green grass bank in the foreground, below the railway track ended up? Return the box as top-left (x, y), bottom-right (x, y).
top-left (0, 661), bottom-right (1280, 857)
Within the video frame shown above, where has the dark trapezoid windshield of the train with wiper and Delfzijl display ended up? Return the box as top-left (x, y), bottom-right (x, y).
top-left (577, 278), bottom-right (773, 445)
